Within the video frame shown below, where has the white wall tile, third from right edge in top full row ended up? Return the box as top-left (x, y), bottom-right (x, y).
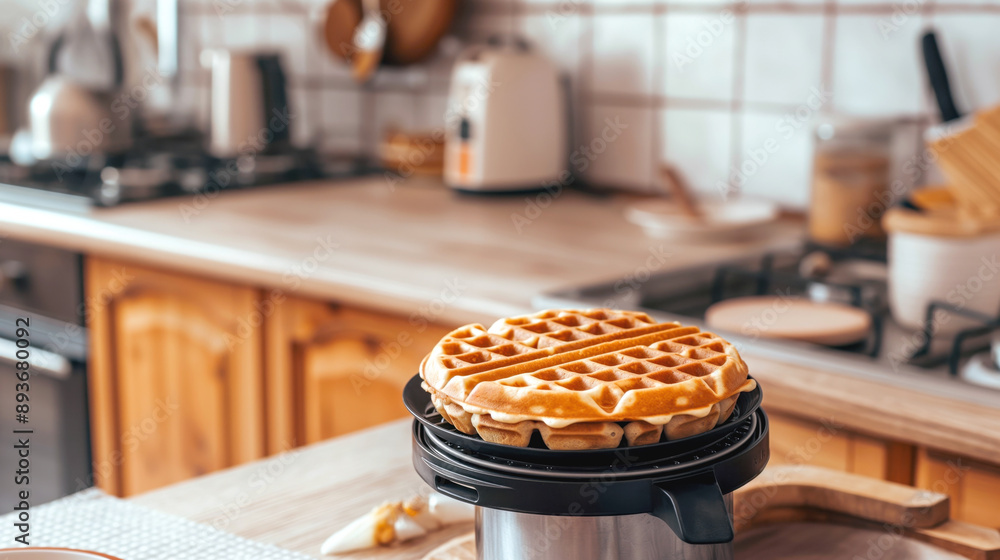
top-left (744, 14), bottom-right (823, 105)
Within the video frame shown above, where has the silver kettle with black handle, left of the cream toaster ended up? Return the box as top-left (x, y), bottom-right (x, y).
top-left (201, 49), bottom-right (294, 158)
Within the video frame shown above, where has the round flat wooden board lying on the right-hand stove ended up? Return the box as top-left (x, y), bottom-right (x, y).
top-left (705, 296), bottom-right (872, 346)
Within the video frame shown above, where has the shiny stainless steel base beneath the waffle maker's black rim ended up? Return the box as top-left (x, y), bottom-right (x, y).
top-left (476, 504), bottom-right (733, 560)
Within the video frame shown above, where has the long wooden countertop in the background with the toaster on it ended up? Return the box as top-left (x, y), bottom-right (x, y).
top-left (0, 176), bottom-right (801, 324)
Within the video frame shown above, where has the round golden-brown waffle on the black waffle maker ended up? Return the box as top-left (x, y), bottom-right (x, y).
top-left (420, 309), bottom-right (756, 449)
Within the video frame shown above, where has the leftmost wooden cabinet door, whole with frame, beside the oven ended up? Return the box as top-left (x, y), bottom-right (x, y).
top-left (86, 258), bottom-right (265, 495)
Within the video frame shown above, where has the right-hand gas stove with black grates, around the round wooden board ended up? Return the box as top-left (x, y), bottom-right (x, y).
top-left (534, 243), bottom-right (1000, 408)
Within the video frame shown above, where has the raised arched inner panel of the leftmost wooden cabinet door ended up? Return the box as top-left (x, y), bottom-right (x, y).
top-left (115, 295), bottom-right (232, 494)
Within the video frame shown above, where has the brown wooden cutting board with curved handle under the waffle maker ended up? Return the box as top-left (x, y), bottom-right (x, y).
top-left (423, 465), bottom-right (1000, 560)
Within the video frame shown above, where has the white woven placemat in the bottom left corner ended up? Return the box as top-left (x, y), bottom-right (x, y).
top-left (0, 489), bottom-right (309, 560)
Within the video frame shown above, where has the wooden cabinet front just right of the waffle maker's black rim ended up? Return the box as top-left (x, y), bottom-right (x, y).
top-left (768, 411), bottom-right (914, 484)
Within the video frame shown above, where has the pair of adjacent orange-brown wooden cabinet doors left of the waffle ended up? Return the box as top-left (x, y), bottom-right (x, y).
top-left (85, 258), bottom-right (450, 496)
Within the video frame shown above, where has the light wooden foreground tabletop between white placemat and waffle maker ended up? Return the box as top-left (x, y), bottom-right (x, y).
top-left (132, 420), bottom-right (456, 560)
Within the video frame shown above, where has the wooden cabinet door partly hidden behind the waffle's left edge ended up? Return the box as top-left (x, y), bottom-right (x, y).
top-left (266, 298), bottom-right (451, 452)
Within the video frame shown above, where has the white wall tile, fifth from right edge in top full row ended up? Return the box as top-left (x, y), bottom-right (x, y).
top-left (590, 13), bottom-right (655, 95)
